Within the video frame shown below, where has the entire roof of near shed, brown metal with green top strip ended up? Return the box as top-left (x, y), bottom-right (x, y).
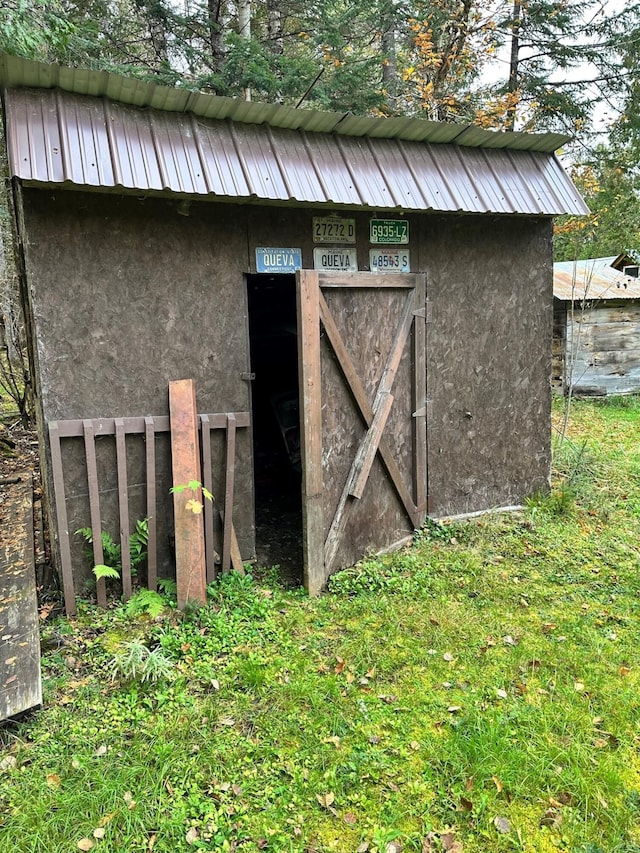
top-left (0, 55), bottom-right (588, 215)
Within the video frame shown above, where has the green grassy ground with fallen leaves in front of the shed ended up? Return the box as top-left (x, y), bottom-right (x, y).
top-left (0, 398), bottom-right (640, 853)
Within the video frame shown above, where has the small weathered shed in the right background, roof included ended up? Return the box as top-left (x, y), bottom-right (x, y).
top-left (552, 254), bottom-right (640, 396)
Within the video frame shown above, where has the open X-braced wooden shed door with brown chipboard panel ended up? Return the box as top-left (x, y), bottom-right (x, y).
top-left (297, 270), bottom-right (427, 594)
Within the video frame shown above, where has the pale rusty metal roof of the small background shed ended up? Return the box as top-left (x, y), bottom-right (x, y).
top-left (553, 256), bottom-right (640, 302)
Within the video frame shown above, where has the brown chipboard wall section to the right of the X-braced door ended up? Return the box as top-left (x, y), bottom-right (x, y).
top-left (421, 217), bottom-right (552, 515)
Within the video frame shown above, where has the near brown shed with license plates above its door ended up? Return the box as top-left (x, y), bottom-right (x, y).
top-left (0, 56), bottom-right (586, 604)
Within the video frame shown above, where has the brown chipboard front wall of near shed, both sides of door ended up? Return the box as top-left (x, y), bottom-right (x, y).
top-left (17, 189), bottom-right (552, 584)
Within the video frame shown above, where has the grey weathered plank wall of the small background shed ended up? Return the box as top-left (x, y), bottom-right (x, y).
top-left (564, 300), bottom-right (640, 395)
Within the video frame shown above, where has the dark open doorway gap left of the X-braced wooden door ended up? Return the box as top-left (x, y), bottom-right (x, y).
top-left (247, 274), bottom-right (303, 584)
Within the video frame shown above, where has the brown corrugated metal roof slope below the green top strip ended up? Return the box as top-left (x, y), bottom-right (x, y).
top-left (5, 88), bottom-right (587, 215)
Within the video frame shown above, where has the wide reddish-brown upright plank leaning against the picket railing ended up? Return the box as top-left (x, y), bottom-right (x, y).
top-left (169, 379), bottom-right (207, 608)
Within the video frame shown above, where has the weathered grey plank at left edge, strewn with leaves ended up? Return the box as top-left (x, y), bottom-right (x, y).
top-left (0, 471), bottom-right (42, 720)
